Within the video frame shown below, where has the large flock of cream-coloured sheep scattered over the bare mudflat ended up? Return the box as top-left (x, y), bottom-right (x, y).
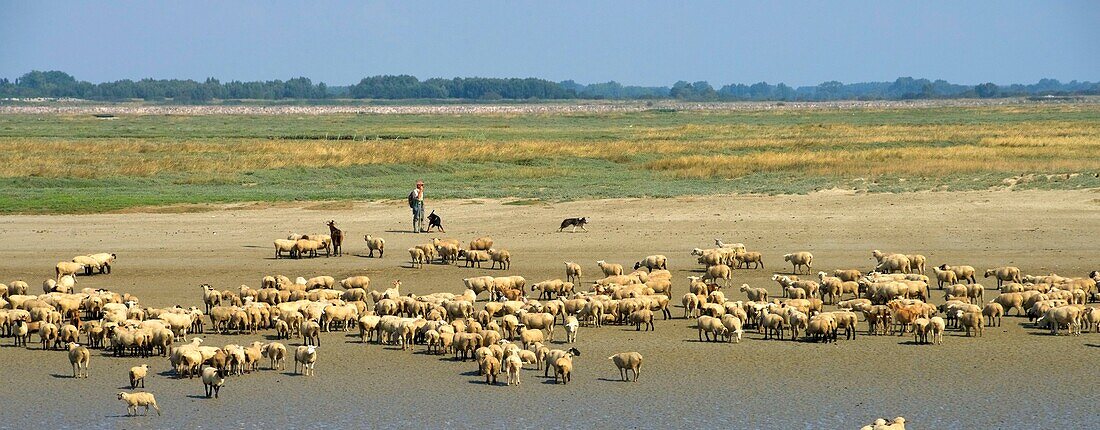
top-left (0, 232), bottom-right (1100, 429)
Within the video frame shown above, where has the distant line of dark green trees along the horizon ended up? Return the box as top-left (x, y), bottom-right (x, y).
top-left (0, 70), bottom-right (1100, 103)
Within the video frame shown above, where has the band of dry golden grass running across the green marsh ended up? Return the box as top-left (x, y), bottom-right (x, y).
top-left (0, 107), bottom-right (1100, 181)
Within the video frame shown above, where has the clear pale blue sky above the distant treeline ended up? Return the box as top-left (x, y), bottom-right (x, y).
top-left (0, 0), bottom-right (1100, 86)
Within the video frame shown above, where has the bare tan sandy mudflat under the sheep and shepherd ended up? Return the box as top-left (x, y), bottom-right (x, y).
top-left (0, 191), bottom-right (1100, 429)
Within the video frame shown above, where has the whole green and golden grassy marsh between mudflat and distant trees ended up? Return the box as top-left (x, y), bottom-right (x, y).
top-left (0, 103), bottom-right (1100, 213)
